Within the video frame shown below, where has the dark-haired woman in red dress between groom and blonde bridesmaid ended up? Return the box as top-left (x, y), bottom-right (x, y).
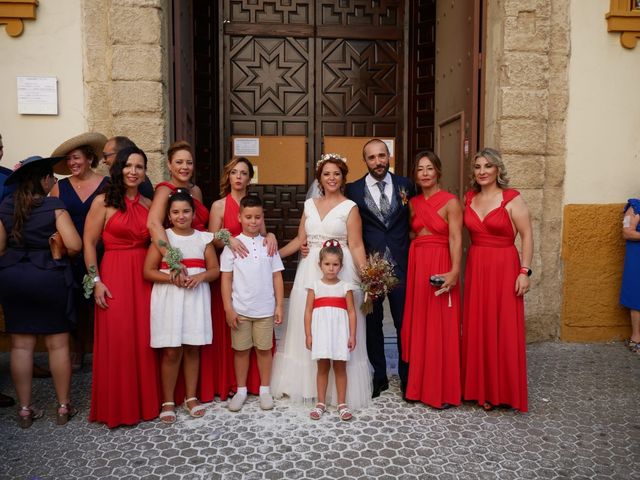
top-left (401, 152), bottom-right (462, 409)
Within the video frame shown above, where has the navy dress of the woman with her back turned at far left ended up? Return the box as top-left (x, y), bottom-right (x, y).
top-left (0, 196), bottom-right (75, 334)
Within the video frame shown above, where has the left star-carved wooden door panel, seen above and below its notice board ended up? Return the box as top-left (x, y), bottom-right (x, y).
top-left (224, 26), bottom-right (314, 268)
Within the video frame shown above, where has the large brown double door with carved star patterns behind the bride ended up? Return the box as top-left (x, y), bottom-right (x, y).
top-left (221, 0), bottom-right (404, 280)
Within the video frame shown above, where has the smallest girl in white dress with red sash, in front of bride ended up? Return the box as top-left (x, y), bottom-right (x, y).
top-left (304, 239), bottom-right (357, 421)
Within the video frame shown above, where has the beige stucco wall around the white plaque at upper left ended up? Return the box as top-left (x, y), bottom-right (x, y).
top-left (0, 0), bottom-right (86, 167)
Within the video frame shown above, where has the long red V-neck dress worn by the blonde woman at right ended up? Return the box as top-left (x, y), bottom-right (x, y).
top-left (462, 189), bottom-right (528, 412)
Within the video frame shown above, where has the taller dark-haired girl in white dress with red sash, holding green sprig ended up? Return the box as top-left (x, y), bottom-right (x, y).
top-left (144, 188), bottom-right (220, 423)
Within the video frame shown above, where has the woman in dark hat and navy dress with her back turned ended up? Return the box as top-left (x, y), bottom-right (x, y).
top-left (0, 157), bottom-right (82, 428)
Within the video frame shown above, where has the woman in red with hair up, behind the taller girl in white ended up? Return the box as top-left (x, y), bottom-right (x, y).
top-left (147, 140), bottom-right (213, 409)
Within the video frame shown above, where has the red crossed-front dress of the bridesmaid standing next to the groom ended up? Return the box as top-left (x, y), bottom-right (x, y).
top-left (401, 190), bottom-right (462, 408)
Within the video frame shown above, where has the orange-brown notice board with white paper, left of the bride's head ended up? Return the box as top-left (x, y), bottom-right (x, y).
top-left (231, 135), bottom-right (307, 185)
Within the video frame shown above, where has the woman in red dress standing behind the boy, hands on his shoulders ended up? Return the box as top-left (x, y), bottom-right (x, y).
top-left (205, 157), bottom-right (278, 401)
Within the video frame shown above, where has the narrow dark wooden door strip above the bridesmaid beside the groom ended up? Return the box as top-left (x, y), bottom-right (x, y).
top-left (407, 0), bottom-right (436, 161)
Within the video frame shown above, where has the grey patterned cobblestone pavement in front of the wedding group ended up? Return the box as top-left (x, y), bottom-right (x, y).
top-left (0, 343), bottom-right (640, 479)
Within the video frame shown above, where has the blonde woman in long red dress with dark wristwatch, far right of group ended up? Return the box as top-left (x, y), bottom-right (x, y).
top-left (462, 148), bottom-right (533, 412)
